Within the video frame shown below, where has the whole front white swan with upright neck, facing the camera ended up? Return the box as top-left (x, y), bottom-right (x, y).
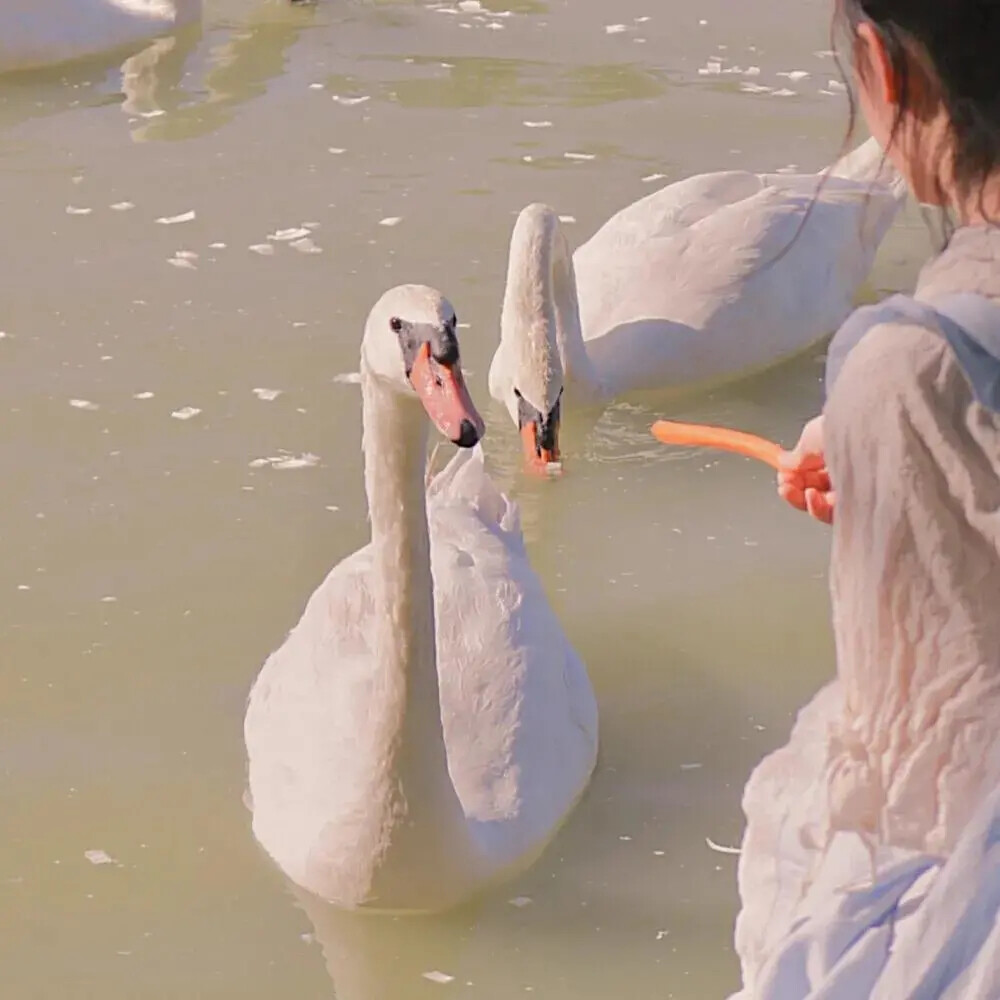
top-left (244, 285), bottom-right (597, 911)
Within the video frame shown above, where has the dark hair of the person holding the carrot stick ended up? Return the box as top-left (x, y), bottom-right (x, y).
top-left (834, 0), bottom-right (1000, 214)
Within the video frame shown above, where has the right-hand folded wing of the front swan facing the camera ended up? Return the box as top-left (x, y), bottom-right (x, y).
top-left (430, 448), bottom-right (598, 862)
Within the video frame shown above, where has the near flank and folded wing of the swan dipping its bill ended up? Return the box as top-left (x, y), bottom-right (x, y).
top-left (574, 175), bottom-right (900, 393)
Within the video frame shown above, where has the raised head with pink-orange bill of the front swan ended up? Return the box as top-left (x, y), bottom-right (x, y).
top-left (361, 285), bottom-right (486, 448)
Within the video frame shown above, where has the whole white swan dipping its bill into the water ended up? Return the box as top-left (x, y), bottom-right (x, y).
top-left (489, 139), bottom-right (906, 472)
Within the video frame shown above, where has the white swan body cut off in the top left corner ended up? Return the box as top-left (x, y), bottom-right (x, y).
top-left (0, 0), bottom-right (201, 72)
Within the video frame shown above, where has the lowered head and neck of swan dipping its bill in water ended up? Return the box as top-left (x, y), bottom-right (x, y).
top-left (490, 204), bottom-right (570, 470)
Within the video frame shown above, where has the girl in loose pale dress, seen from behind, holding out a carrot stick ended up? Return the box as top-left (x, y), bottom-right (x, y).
top-left (736, 0), bottom-right (1000, 1000)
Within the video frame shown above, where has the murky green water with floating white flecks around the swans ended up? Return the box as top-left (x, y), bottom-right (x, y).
top-left (0, 0), bottom-right (927, 1000)
